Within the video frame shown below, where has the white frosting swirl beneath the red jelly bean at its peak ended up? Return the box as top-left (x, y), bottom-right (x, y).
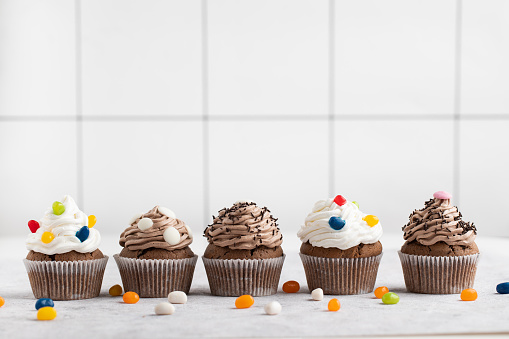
top-left (297, 198), bottom-right (383, 250)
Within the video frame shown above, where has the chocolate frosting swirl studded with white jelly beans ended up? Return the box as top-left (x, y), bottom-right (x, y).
top-left (119, 206), bottom-right (193, 251)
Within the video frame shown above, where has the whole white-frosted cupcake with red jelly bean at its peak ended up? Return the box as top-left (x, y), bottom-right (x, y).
top-left (297, 195), bottom-right (382, 294)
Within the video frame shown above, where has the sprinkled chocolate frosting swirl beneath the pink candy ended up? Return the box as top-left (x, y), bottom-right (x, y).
top-left (403, 198), bottom-right (477, 246)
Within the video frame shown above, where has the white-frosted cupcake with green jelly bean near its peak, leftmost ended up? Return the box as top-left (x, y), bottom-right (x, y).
top-left (24, 195), bottom-right (108, 300)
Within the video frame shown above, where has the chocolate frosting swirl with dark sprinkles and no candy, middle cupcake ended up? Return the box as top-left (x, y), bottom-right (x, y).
top-left (204, 202), bottom-right (283, 250)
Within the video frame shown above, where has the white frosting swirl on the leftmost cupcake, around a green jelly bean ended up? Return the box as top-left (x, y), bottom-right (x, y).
top-left (26, 195), bottom-right (101, 255)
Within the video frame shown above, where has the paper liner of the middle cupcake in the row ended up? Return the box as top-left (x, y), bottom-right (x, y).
top-left (202, 254), bottom-right (285, 297)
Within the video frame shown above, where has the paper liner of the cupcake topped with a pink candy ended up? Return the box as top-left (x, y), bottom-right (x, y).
top-left (398, 251), bottom-right (479, 294)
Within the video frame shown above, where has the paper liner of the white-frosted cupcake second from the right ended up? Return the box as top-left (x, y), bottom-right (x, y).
top-left (300, 253), bottom-right (383, 295)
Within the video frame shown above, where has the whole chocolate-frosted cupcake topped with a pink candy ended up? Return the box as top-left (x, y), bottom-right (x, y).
top-left (399, 191), bottom-right (479, 294)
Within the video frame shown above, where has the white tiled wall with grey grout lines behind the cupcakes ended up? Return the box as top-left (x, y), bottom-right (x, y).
top-left (0, 0), bottom-right (509, 241)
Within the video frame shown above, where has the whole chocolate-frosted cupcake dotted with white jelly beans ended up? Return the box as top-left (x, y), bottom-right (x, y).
top-left (113, 206), bottom-right (198, 298)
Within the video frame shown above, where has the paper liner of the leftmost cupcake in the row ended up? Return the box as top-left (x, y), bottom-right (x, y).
top-left (23, 256), bottom-right (108, 300)
